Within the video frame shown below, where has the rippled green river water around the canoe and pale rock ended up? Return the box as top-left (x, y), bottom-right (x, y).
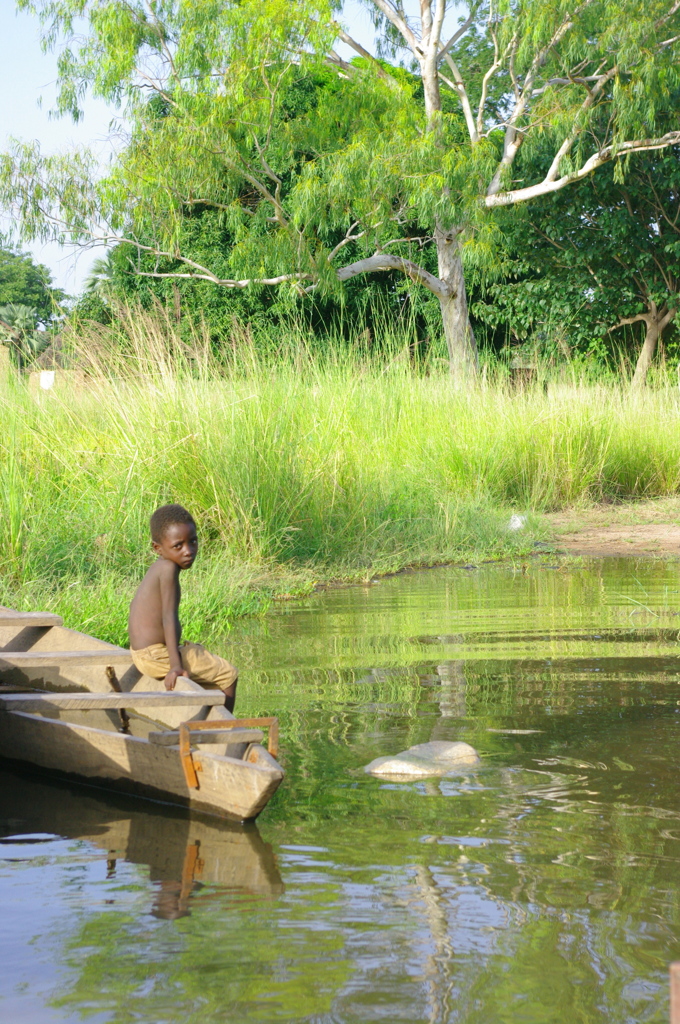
top-left (0, 559), bottom-right (680, 1024)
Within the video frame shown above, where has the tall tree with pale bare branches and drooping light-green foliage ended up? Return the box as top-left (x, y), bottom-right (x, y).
top-left (0, 0), bottom-right (680, 378)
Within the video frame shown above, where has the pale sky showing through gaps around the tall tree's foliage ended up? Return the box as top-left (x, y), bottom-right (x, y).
top-left (0, 0), bottom-right (456, 295)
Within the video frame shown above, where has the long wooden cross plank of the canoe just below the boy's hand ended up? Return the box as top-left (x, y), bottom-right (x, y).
top-left (0, 690), bottom-right (224, 712)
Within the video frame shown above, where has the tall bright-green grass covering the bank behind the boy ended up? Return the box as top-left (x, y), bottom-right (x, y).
top-left (0, 313), bottom-right (680, 642)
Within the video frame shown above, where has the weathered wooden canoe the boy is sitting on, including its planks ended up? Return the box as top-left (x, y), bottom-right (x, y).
top-left (0, 606), bottom-right (284, 821)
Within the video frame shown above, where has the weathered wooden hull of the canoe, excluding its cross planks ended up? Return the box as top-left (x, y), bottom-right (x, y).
top-left (0, 608), bottom-right (284, 821)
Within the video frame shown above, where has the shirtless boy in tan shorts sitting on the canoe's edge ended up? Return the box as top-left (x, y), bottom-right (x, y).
top-left (128, 505), bottom-right (239, 712)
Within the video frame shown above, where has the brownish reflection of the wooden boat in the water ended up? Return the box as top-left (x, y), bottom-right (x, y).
top-left (0, 770), bottom-right (284, 920)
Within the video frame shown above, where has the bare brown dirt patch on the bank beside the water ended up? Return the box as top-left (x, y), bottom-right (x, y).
top-left (545, 498), bottom-right (680, 558)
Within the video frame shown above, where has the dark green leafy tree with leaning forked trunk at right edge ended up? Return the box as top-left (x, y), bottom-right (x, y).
top-left (475, 150), bottom-right (680, 387)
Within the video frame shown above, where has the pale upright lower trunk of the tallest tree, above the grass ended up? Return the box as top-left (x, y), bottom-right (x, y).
top-left (435, 228), bottom-right (478, 383)
